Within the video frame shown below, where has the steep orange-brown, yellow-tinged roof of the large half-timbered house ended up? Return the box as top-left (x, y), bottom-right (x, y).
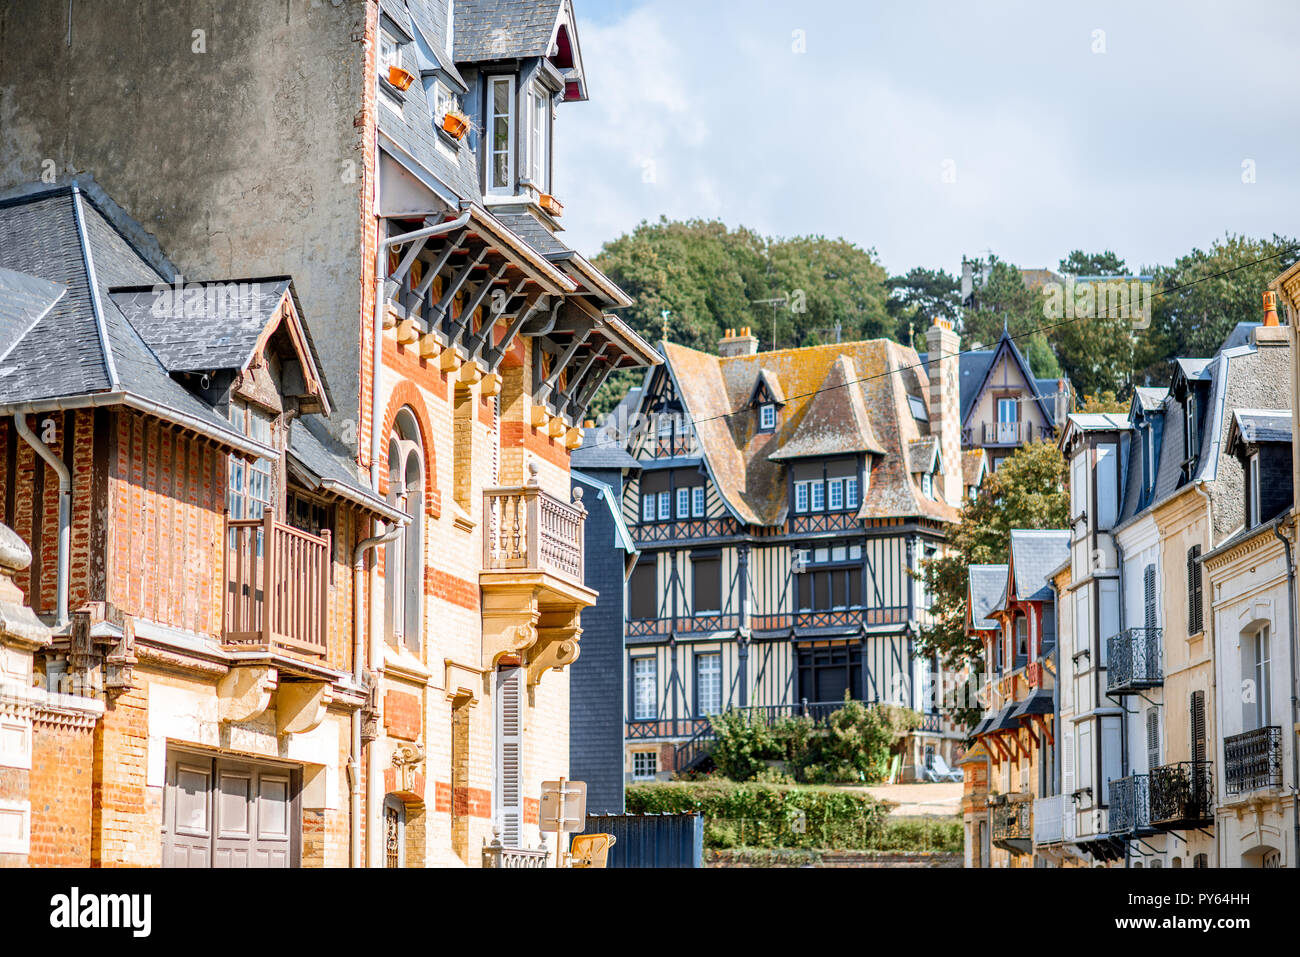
top-left (659, 339), bottom-right (958, 525)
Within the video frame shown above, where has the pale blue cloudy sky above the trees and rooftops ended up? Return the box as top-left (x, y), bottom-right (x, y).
top-left (555, 0), bottom-right (1300, 272)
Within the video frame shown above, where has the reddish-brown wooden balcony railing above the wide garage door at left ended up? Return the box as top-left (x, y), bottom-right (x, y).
top-left (222, 512), bottom-right (330, 655)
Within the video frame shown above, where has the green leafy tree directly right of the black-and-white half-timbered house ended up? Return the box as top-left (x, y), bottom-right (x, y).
top-left (917, 442), bottom-right (1069, 718)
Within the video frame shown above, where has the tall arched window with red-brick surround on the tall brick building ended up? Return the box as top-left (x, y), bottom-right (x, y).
top-left (384, 408), bottom-right (425, 651)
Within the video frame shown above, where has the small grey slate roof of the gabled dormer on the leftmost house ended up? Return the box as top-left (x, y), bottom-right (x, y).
top-left (109, 277), bottom-right (290, 372)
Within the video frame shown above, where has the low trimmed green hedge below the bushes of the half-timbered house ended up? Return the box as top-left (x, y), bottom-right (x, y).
top-left (627, 779), bottom-right (888, 849)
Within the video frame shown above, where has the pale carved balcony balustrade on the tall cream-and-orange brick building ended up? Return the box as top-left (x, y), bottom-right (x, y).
top-left (484, 485), bottom-right (586, 583)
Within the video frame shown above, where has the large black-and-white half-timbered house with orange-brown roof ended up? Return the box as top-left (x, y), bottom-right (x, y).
top-left (605, 322), bottom-right (966, 778)
